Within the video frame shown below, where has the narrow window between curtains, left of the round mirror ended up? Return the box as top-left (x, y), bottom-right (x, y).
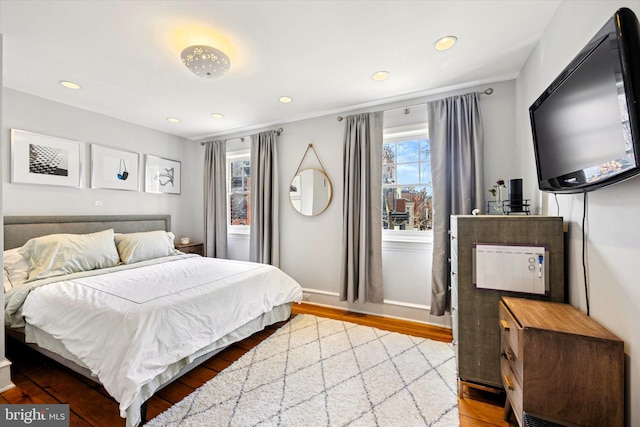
top-left (227, 151), bottom-right (251, 232)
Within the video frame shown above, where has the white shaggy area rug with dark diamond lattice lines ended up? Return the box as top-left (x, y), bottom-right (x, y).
top-left (146, 314), bottom-right (459, 427)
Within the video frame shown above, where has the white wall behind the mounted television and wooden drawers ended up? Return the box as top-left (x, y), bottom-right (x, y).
top-left (516, 0), bottom-right (640, 426)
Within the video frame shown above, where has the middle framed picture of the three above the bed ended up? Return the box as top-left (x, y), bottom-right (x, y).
top-left (91, 144), bottom-right (140, 191)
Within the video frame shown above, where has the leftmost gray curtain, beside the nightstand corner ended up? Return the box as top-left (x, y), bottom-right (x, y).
top-left (204, 141), bottom-right (227, 258)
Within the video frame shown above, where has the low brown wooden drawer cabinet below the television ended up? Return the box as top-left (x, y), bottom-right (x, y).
top-left (499, 297), bottom-right (624, 426)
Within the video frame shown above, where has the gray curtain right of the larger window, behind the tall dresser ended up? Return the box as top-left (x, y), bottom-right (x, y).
top-left (427, 92), bottom-right (484, 316)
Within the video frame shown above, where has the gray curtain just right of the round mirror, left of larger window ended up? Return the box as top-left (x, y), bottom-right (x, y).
top-left (340, 112), bottom-right (383, 303)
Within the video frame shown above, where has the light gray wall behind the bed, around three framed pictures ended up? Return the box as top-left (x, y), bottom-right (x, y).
top-left (2, 88), bottom-right (202, 241)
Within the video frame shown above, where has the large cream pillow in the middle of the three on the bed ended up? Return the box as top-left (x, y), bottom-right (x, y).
top-left (18, 230), bottom-right (119, 282)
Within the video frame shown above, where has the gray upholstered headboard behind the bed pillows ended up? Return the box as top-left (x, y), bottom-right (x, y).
top-left (4, 215), bottom-right (171, 250)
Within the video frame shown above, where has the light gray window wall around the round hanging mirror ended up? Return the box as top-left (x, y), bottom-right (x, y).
top-left (210, 80), bottom-right (530, 326)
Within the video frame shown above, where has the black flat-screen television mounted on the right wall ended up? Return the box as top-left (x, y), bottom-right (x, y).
top-left (529, 8), bottom-right (640, 193)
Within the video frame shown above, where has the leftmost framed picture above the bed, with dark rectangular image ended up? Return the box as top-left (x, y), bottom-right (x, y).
top-left (11, 129), bottom-right (81, 187)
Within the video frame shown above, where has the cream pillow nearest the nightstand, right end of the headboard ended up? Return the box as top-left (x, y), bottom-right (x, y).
top-left (115, 230), bottom-right (180, 264)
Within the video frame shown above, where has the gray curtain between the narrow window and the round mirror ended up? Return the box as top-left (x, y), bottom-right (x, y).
top-left (249, 131), bottom-right (280, 267)
